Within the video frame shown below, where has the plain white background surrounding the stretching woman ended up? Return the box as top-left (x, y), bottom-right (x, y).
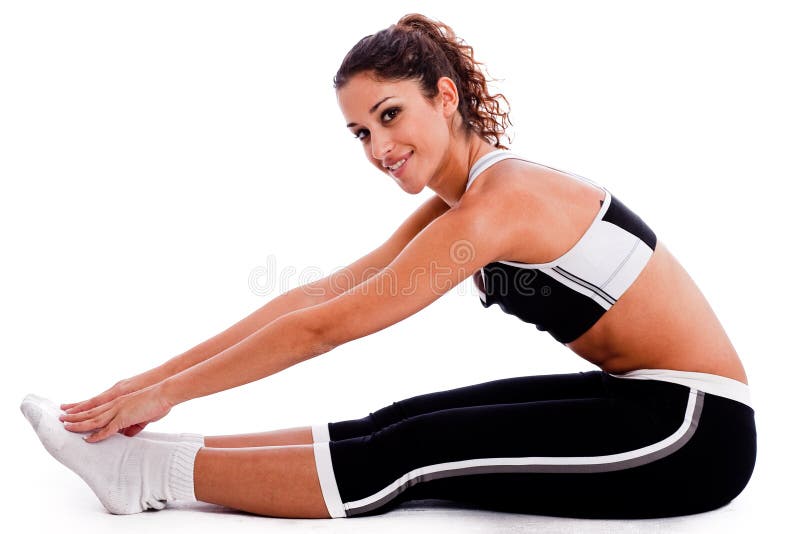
top-left (0, 0), bottom-right (800, 532)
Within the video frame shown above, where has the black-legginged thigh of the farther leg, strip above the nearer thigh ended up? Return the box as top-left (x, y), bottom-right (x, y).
top-left (328, 371), bottom-right (605, 441)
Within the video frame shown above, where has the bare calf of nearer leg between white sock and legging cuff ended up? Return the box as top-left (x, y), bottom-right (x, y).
top-left (194, 446), bottom-right (330, 519)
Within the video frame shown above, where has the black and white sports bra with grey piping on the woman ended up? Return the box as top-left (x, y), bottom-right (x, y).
top-left (467, 149), bottom-right (656, 344)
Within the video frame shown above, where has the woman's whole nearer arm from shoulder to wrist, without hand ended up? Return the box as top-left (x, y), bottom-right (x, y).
top-left (159, 201), bottom-right (504, 406)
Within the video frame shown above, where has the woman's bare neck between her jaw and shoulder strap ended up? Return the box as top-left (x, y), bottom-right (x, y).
top-left (428, 132), bottom-right (496, 208)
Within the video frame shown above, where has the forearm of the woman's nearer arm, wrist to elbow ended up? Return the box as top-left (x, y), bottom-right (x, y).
top-left (159, 312), bottom-right (332, 405)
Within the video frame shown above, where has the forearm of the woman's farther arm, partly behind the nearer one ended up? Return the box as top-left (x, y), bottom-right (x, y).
top-left (155, 288), bottom-right (319, 384)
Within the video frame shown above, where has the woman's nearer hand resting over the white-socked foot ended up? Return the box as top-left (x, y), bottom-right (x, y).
top-left (59, 384), bottom-right (172, 443)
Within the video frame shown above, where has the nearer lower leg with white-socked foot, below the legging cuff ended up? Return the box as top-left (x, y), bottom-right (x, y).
top-left (20, 395), bottom-right (330, 518)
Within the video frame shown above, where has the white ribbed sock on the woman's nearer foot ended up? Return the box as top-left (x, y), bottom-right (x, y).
top-left (20, 395), bottom-right (201, 514)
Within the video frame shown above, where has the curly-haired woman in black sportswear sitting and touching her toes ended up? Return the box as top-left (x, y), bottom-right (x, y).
top-left (22, 14), bottom-right (756, 518)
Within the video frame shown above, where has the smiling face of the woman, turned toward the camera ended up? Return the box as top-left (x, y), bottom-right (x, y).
top-left (337, 72), bottom-right (458, 194)
